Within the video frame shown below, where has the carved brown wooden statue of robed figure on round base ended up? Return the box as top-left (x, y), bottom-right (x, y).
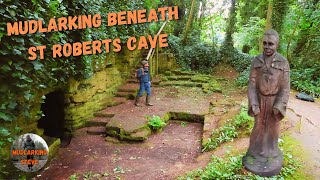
top-left (243, 29), bottom-right (290, 176)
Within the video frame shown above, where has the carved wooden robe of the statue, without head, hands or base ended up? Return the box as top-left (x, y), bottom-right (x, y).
top-left (247, 52), bottom-right (290, 157)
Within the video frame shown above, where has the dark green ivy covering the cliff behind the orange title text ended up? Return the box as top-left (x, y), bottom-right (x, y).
top-left (0, 0), bottom-right (150, 176)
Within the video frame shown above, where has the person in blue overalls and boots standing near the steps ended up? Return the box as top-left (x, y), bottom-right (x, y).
top-left (134, 60), bottom-right (153, 106)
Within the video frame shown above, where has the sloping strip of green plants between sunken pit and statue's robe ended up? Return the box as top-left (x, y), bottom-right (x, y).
top-left (202, 106), bottom-right (253, 151)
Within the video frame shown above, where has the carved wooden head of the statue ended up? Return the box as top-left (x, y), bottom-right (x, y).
top-left (263, 29), bottom-right (279, 56)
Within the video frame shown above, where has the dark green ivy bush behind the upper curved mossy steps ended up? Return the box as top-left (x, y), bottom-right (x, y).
top-left (168, 35), bottom-right (218, 73)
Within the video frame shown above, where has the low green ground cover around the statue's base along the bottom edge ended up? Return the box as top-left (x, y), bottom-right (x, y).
top-left (178, 135), bottom-right (312, 180)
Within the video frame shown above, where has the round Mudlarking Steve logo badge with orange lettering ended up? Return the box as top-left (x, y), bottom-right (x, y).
top-left (10, 133), bottom-right (49, 172)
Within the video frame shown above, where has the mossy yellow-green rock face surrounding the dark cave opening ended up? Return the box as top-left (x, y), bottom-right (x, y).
top-left (0, 49), bottom-right (141, 163)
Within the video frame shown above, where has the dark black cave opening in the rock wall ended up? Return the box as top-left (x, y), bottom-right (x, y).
top-left (38, 91), bottom-right (65, 138)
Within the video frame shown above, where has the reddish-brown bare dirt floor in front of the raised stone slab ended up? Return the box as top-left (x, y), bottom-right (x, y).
top-left (36, 121), bottom-right (202, 180)
